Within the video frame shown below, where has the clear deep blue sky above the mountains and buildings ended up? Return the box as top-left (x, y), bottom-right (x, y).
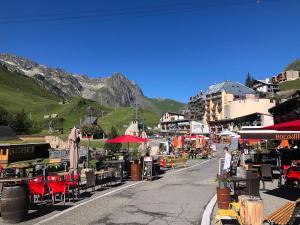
top-left (0, 0), bottom-right (300, 102)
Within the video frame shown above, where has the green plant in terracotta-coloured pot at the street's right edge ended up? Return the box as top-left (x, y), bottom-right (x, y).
top-left (216, 174), bottom-right (231, 209)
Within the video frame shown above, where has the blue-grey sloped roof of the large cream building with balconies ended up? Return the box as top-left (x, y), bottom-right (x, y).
top-left (205, 81), bottom-right (255, 96)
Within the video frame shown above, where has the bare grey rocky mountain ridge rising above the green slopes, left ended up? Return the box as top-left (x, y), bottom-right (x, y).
top-left (0, 54), bottom-right (146, 107)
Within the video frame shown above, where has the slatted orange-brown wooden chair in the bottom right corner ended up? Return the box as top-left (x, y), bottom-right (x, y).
top-left (265, 199), bottom-right (300, 225)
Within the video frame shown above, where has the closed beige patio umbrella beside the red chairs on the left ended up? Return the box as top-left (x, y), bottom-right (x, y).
top-left (68, 127), bottom-right (79, 174)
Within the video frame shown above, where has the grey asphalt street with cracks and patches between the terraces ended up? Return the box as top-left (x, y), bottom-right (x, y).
top-left (11, 159), bottom-right (217, 225)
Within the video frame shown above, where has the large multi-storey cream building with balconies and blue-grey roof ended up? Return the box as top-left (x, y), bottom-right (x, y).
top-left (188, 81), bottom-right (256, 123)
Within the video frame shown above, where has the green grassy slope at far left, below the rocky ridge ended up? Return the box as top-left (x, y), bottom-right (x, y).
top-left (0, 68), bottom-right (111, 133)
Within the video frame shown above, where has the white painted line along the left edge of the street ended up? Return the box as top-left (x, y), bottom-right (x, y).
top-left (35, 160), bottom-right (210, 225)
